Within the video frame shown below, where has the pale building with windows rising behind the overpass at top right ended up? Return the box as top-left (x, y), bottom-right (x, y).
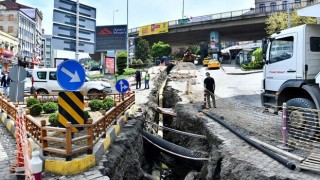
top-left (255, 0), bottom-right (319, 12)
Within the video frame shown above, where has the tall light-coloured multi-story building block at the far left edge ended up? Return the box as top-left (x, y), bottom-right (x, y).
top-left (0, 0), bottom-right (43, 66)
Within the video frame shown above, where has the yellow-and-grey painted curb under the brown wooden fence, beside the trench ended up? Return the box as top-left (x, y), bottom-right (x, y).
top-left (45, 105), bottom-right (140, 175)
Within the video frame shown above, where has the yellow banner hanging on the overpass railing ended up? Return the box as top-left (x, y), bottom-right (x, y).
top-left (139, 22), bottom-right (169, 36)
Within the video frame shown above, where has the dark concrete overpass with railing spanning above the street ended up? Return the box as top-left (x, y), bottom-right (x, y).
top-left (129, 2), bottom-right (318, 46)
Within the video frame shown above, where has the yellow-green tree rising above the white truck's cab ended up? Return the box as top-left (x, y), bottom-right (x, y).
top-left (266, 11), bottom-right (317, 35)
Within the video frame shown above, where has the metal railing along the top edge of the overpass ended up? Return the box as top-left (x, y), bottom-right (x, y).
top-left (128, 1), bottom-right (318, 34)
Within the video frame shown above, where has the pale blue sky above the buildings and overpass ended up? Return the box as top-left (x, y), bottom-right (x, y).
top-left (17, 0), bottom-right (254, 34)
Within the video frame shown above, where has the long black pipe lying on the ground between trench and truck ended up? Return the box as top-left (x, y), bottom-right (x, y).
top-left (198, 109), bottom-right (296, 170)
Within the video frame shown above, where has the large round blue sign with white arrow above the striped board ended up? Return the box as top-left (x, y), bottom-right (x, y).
top-left (57, 60), bottom-right (86, 91)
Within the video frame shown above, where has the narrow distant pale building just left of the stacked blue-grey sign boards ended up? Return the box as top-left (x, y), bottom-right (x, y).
top-left (42, 35), bottom-right (54, 68)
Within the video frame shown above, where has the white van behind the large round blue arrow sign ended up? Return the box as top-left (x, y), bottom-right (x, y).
top-left (32, 68), bottom-right (112, 94)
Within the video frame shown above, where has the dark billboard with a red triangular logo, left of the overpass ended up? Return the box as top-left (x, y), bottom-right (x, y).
top-left (96, 25), bottom-right (127, 52)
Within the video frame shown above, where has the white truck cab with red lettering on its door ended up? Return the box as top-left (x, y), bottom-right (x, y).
top-left (261, 24), bottom-right (320, 112)
